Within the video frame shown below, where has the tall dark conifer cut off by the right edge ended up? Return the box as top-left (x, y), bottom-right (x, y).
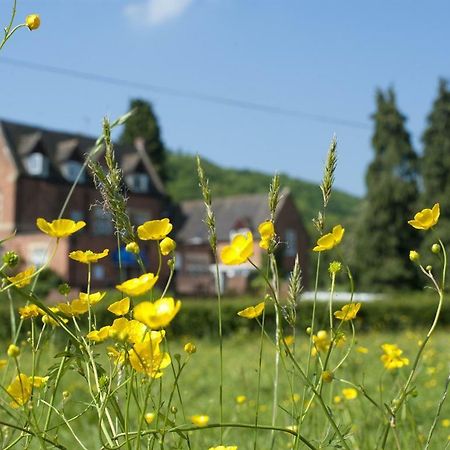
top-left (421, 80), bottom-right (450, 250)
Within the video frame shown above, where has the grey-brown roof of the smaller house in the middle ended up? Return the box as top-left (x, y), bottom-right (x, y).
top-left (177, 189), bottom-right (290, 243)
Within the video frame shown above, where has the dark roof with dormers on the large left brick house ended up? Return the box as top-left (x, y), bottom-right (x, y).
top-left (0, 119), bottom-right (164, 195)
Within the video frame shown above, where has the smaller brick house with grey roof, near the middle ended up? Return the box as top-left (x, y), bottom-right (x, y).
top-left (176, 189), bottom-right (310, 295)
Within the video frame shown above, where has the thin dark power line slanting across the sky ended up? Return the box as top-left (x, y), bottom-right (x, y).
top-left (0, 57), bottom-right (371, 130)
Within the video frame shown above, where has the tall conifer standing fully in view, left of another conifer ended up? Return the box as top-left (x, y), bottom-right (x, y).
top-left (354, 89), bottom-right (420, 291)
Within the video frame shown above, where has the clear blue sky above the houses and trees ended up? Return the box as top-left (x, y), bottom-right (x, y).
top-left (0, 0), bottom-right (450, 195)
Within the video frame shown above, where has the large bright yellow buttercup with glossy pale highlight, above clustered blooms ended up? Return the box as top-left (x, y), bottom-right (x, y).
top-left (133, 297), bottom-right (181, 329)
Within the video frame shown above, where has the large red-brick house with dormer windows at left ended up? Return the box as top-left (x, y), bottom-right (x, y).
top-left (0, 120), bottom-right (168, 288)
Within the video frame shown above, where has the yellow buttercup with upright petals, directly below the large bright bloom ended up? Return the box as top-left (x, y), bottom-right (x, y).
top-left (129, 330), bottom-right (171, 378)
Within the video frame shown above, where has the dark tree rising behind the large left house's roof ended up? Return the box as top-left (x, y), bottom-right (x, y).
top-left (119, 99), bottom-right (167, 181)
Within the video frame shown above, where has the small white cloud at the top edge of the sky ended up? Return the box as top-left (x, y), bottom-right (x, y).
top-left (125, 0), bottom-right (193, 26)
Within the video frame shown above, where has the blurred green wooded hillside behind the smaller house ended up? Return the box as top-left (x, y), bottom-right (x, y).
top-left (166, 152), bottom-right (361, 231)
